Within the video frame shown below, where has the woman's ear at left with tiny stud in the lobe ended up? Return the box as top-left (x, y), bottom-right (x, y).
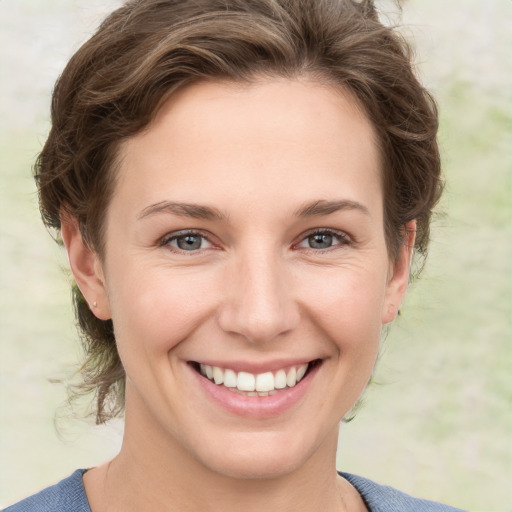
top-left (61, 214), bottom-right (111, 320)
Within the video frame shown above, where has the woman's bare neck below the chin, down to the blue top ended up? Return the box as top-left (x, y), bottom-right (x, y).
top-left (83, 386), bottom-right (367, 512)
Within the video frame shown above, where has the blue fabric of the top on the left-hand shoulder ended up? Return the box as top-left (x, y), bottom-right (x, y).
top-left (3, 469), bottom-right (91, 512)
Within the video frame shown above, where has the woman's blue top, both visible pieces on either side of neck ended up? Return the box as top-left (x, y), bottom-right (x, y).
top-left (4, 469), bottom-right (468, 512)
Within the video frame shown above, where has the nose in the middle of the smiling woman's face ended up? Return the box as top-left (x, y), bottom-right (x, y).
top-left (218, 247), bottom-right (300, 344)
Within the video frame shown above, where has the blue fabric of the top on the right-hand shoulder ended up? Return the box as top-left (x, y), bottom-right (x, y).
top-left (339, 473), bottom-right (463, 512)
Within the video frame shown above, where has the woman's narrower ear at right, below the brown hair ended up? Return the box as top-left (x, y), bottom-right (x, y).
top-left (382, 220), bottom-right (416, 324)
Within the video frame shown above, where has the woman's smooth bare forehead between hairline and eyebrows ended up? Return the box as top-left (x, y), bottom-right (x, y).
top-left (114, 79), bottom-right (381, 216)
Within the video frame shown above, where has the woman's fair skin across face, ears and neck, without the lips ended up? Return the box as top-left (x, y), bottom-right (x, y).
top-left (62, 79), bottom-right (415, 512)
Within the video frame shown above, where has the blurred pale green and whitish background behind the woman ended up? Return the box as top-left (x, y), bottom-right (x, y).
top-left (0, 0), bottom-right (512, 512)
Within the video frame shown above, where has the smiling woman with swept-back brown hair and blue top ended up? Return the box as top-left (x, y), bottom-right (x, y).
top-left (7, 0), bottom-right (468, 512)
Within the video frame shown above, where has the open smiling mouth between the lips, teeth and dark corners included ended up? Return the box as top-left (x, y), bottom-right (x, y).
top-left (190, 359), bottom-right (321, 397)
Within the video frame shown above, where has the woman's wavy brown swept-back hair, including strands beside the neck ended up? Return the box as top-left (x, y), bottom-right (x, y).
top-left (35, 0), bottom-right (442, 423)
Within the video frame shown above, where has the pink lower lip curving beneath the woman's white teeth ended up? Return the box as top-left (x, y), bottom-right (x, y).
top-left (189, 365), bottom-right (321, 419)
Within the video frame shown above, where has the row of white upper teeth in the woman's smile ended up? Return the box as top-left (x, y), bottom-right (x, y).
top-left (200, 363), bottom-right (308, 394)
